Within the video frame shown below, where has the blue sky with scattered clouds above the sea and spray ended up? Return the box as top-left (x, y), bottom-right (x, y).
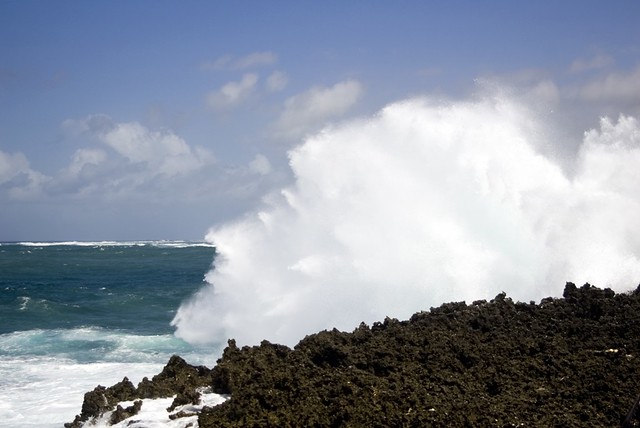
top-left (0, 0), bottom-right (640, 241)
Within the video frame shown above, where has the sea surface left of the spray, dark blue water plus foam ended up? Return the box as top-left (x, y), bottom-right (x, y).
top-left (0, 241), bottom-right (221, 428)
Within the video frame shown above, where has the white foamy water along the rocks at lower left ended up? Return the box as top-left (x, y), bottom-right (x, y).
top-left (0, 328), bottom-right (219, 428)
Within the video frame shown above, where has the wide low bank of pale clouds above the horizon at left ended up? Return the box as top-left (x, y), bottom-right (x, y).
top-left (0, 114), bottom-right (278, 212)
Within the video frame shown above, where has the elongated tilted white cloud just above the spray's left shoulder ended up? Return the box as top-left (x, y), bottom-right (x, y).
top-left (276, 80), bottom-right (363, 138)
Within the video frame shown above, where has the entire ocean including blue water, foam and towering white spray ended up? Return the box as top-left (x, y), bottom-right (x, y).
top-left (0, 98), bottom-right (640, 428)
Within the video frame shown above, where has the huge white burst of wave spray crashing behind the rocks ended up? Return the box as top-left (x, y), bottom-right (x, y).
top-left (173, 92), bottom-right (640, 345)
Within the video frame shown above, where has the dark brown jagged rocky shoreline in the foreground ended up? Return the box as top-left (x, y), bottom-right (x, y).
top-left (65, 283), bottom-right (640, 428)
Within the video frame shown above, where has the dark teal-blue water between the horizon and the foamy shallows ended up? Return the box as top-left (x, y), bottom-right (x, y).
top-left (0, 243), bottom-right (215, 334)
